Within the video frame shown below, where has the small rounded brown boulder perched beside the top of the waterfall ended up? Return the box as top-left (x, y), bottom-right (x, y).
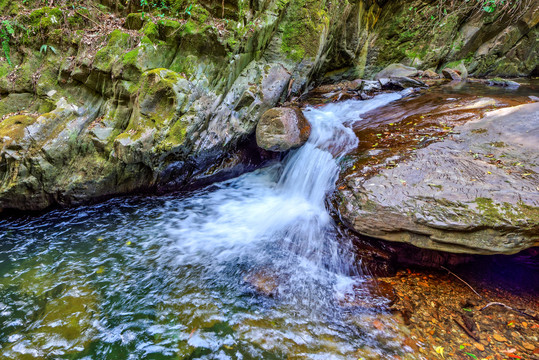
top-left (256, 107), bottom-right (311, 151)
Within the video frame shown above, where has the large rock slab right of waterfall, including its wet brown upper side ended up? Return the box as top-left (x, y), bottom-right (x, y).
top-left (337, 83), bottom-right (539, 254)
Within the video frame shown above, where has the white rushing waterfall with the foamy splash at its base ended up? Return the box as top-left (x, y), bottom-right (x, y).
top-left (162, 93), bottom-right (401, 306)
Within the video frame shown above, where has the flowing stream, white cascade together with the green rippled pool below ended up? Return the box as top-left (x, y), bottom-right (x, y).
top-left (0, 93), bottom-right (403, 359)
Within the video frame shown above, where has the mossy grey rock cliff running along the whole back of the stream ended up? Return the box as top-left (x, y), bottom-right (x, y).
top-left (0, 0), bottom-right (539, 210)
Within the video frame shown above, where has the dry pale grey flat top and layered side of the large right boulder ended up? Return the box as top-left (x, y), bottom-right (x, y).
top-left (338, 103), bottom-right (539, 254)
